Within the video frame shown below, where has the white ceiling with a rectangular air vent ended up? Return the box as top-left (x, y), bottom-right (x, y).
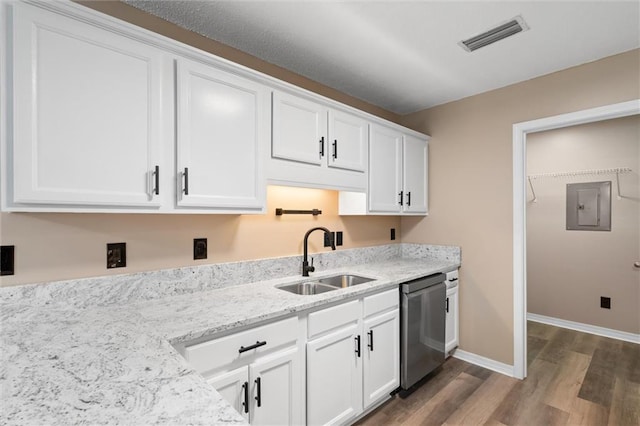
top-left (124, 0), bottom-right (640, 114)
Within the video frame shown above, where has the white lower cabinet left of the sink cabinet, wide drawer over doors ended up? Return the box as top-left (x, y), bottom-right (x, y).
top-left (184, 317), bottom-right (304, 425)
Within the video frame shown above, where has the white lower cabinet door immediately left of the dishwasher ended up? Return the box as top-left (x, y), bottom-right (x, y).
top-left (363, 309), bottom-right (400, 410)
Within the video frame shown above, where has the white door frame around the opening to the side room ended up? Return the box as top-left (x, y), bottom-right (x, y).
top-left (513, 99), bottom-right (640, 379)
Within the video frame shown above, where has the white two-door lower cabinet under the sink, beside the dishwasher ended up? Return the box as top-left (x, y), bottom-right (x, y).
top-left (307, 289), bottom-right (400, 425)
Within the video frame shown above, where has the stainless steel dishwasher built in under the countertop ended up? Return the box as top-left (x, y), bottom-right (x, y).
top-left (400, 274), bottom-right (447, 396)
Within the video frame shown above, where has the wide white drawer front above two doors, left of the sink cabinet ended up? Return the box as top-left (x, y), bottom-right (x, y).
top-left (185, 317), bottom-right (298, 375)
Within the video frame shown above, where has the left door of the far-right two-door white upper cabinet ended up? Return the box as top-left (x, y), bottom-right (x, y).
top-left (369, 125), bottom-right (402, 213)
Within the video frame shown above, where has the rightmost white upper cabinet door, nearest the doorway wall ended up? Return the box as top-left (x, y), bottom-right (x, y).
top-left (402, 135), bottom-right (428, 213)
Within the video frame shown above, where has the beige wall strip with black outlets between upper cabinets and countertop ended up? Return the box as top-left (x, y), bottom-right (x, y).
top-left (0, 186), bottom-right (400, 286)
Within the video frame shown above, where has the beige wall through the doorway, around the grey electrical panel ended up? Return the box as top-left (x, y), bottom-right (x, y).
top-left (527, 116), bottom-right (640, 333)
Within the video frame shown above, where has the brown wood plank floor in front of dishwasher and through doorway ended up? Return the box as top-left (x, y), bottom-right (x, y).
top-left (357, 321), bottom-right (640, 426)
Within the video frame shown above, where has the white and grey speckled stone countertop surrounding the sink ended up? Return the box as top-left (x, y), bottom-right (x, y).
top-left (0, 245), bottom-right (460, 425)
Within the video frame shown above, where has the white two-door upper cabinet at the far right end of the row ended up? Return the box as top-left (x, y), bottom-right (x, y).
top-left (368, 125), bottom-right (428, 215)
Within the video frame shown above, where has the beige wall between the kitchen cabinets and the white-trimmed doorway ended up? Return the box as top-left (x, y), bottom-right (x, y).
top-left (401, 50), bottom-right (640, 364)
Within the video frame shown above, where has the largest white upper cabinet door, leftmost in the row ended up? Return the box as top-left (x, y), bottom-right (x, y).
top-left (9, 4), bottom-right (166, 208)
